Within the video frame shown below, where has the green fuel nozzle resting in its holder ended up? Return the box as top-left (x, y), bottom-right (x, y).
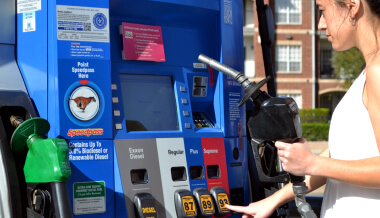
top-left (10, 116), bottom-right (71, 183)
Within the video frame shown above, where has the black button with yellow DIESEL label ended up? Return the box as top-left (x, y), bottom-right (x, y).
top-left (133, 193), bottom-right (158, 218)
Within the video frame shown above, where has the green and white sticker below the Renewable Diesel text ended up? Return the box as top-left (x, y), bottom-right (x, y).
top-left (73, 181), bottom-right (106, 215)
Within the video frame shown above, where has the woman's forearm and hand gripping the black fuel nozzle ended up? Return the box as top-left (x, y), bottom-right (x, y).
top-left (276, 139), bottom-right (380, 188)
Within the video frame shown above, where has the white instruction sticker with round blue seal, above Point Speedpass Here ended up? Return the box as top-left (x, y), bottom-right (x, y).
top-left (57, 5), bottom-right (110, 42)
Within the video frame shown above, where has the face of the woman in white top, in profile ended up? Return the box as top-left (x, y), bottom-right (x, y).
top-left (317, 0), bottom-right (354, 51)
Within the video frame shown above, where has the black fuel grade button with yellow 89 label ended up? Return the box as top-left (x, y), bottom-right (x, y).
top-left (193, 188), bottom-right (215, 216)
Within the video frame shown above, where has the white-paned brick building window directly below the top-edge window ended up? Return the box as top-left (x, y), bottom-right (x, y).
top-left (276, 45), bottom-right (302, 73)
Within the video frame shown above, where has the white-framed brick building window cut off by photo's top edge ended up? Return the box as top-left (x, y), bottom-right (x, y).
top-left (275, 0), bottom-right (302, 24)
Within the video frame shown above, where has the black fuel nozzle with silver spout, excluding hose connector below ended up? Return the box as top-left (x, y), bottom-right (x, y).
top-left (198, 54), bottom-right (304, 183)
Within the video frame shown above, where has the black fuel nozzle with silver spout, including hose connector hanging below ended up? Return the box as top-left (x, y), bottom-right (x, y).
top-left (198, 55), bottom-right (316, 218)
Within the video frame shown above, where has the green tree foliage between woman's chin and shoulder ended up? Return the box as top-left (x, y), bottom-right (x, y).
top-left (331, 48), bottom-right (365, 88)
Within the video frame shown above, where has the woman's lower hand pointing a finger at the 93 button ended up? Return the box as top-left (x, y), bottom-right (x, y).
top-left (226, 196), bottom-right (276, 218)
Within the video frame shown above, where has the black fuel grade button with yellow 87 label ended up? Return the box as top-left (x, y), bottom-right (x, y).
top-left (174, 190), bottom-right (197, 218)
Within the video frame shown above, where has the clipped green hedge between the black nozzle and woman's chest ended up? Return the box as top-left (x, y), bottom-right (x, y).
top-left (299, 108), bottom-right (330, 141)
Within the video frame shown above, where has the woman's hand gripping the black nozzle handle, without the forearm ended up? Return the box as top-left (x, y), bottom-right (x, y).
top-left (275, 138), bottom-right (317, 176)
